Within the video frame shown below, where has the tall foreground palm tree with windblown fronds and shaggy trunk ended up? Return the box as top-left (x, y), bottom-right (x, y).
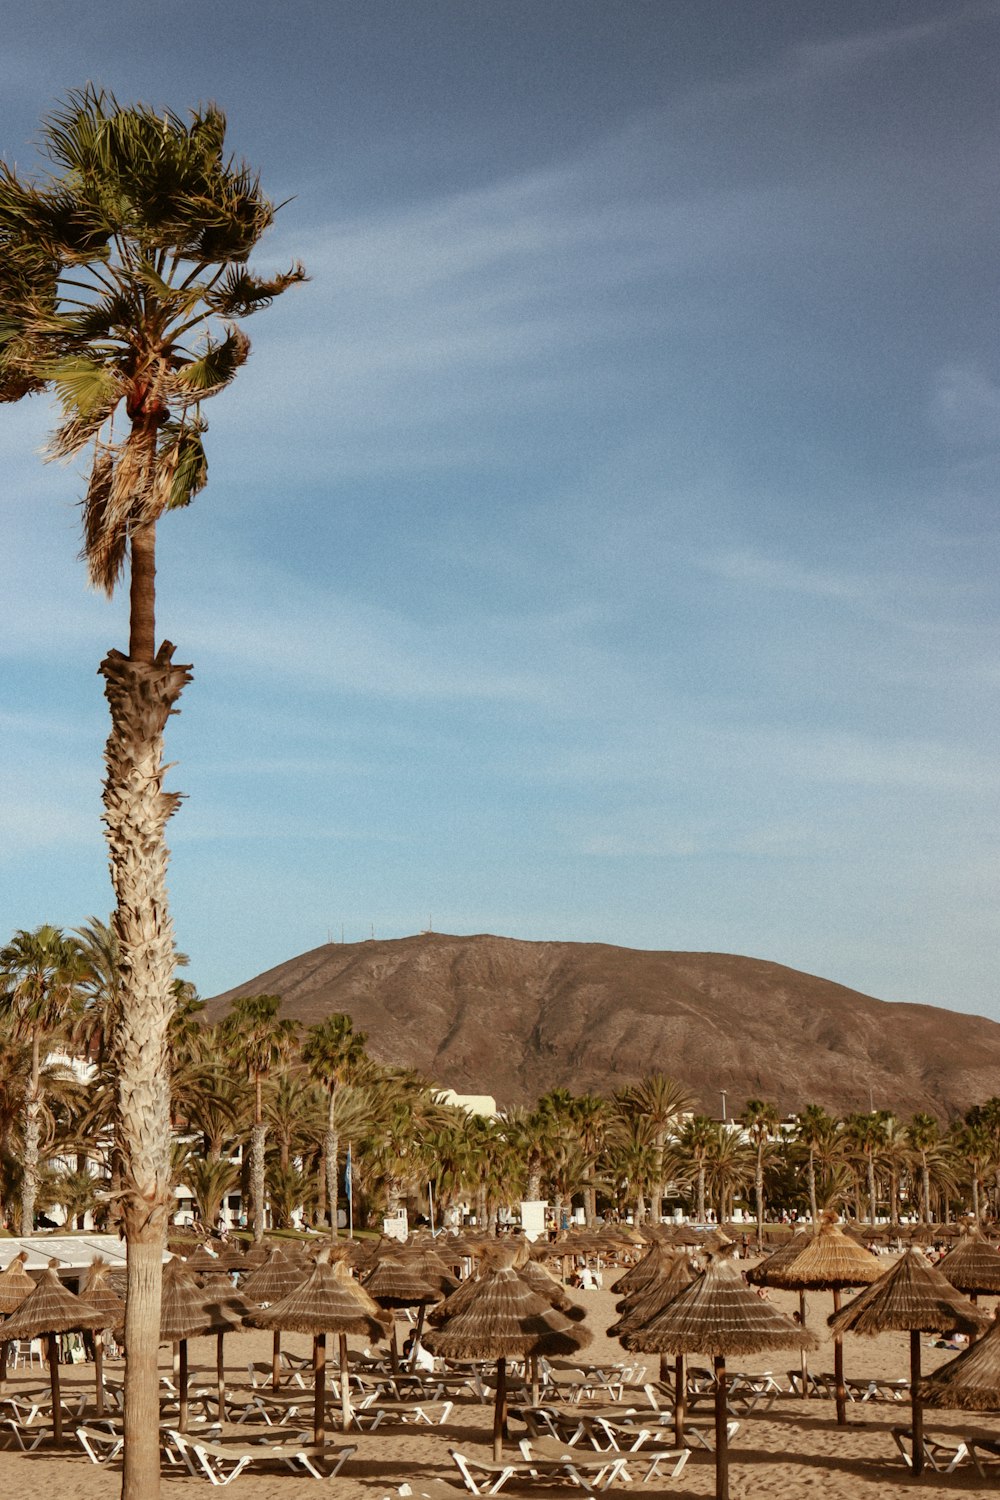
top-left (0, 87), bottom-right (303, 1500)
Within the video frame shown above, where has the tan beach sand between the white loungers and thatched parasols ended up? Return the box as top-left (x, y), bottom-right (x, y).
top-left (0, 1262), bottom-right (1000, 1500)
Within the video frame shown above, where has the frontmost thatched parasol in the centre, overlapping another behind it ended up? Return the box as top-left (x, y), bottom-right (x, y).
top-left (424, 1266), bottom-right (591, 1463)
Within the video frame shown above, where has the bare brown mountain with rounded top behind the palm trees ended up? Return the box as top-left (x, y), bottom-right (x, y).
top-left (207, 933), bottom-right (1000, 1118)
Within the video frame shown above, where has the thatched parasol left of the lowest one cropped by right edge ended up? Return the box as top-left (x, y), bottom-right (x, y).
top-left (829, 1245), bottom-right (987, 1475)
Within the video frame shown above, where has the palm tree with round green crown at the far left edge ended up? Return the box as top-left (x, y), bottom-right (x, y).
top-left (0, 924), bottom-right (84, 1235)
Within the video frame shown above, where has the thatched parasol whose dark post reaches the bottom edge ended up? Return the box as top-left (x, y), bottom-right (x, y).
top-left (622, 1259), bottom-right (816, 1500)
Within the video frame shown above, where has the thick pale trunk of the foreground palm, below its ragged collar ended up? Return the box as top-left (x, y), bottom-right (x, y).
top-left (100, 639), bottom-right (190, 1500)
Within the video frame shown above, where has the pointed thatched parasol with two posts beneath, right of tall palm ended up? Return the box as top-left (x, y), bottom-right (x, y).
top-left (246, 1260), bottom-right (387, 1445)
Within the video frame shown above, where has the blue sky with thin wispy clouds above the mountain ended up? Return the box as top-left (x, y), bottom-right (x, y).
top-left (0, 0), bottom-right (1000, 1019)
